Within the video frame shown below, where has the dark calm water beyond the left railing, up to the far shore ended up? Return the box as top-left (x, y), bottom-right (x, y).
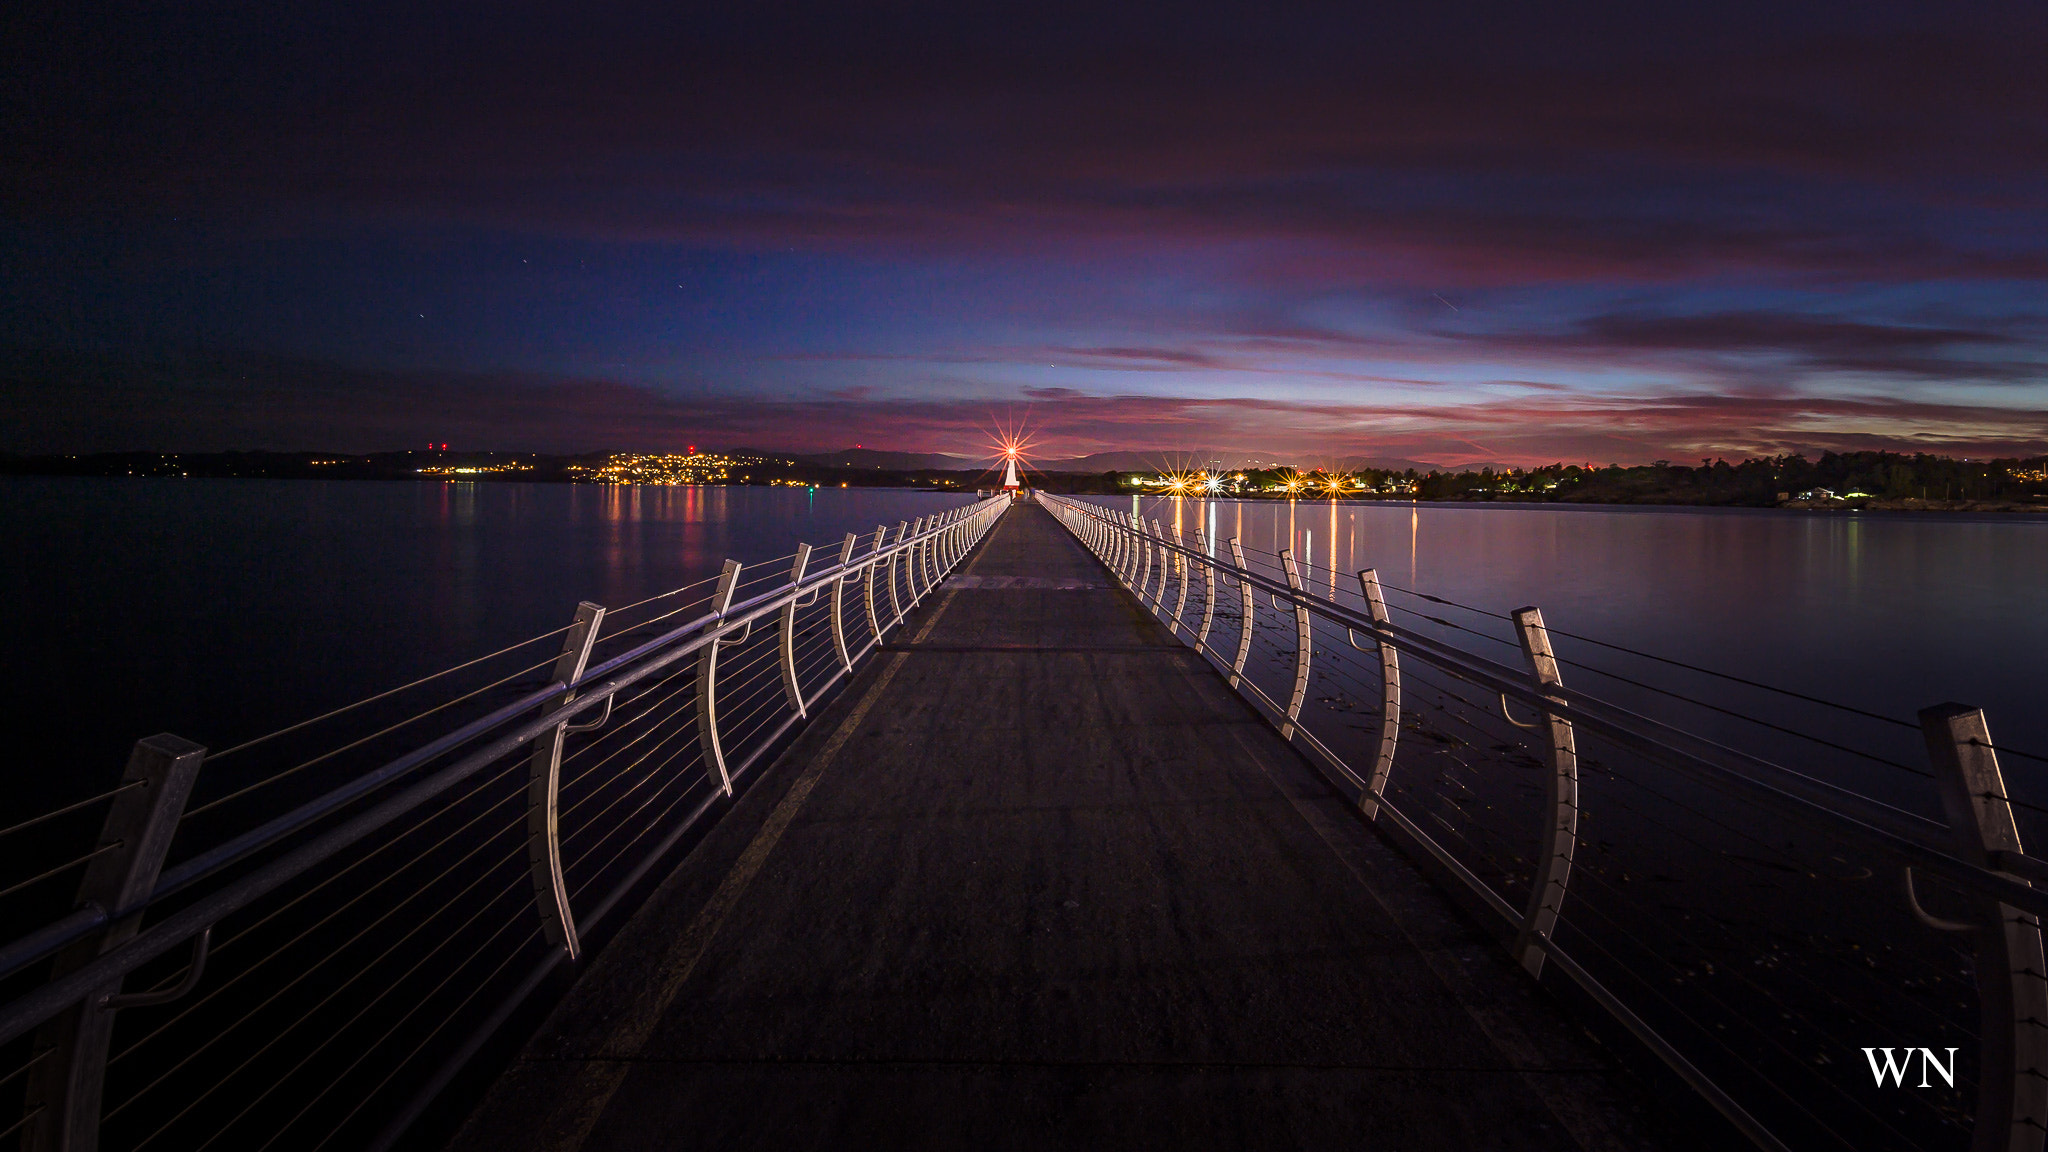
top-left (0, 478), bottom-right (971, 803)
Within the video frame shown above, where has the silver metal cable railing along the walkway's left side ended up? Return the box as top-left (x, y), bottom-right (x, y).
top-left (0, 498), bottom-right (1010, 1152)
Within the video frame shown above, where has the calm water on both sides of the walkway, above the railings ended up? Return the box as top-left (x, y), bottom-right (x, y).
top-left (12, 478), bottom-right (2048, 811)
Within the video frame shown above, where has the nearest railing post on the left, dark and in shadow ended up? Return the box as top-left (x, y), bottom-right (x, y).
top-left (20, 732), bottom-right (207, 1152)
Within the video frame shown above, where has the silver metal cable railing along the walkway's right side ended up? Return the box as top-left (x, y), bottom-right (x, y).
top-left (1036, 494), bottom-right (2048, 1152)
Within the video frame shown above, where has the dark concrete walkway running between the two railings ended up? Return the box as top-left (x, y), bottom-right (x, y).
top-left (455, 506), bottom-right (1687, 1152)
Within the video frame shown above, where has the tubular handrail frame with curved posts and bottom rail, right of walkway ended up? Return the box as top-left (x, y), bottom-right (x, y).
top-left (1038, 494), bottom-right (2048, 1152)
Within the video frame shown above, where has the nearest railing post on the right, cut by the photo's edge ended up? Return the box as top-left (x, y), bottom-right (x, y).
top-left (1919, 703), bottom-right (2048, 1152)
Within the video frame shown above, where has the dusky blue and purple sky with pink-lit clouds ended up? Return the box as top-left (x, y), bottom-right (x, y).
top-left (0, 0), bottom-right (2048, 465)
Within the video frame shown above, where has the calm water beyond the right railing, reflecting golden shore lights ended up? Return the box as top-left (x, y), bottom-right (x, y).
top-left (1098, 498), bottom-right (2048, 808)
